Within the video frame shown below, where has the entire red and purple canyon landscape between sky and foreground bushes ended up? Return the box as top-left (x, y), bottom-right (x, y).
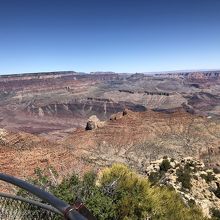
top-left (0, 71), bottom-right (220, 192)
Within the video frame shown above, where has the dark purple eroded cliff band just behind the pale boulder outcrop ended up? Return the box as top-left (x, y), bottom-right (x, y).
top-left (25, 98), bottom-right (146, 120)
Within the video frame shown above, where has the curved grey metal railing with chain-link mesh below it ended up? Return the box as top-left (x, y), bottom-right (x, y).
top-left (0, 173), bottom-right (87, 220)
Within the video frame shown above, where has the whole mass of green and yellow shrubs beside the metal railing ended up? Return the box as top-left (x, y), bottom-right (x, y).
top-left (18, 164), bottom-right (204, 220)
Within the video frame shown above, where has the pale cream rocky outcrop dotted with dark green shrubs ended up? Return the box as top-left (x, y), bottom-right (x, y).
top-left (145, 157), bottom-right (220, 217)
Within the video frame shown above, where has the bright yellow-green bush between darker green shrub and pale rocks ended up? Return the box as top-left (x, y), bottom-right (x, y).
top-left (98, 165), bottom-right (203, 220)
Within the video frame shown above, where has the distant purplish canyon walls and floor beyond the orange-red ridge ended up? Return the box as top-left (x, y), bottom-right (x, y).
top-left (0, 71), bottom-right (220, 139)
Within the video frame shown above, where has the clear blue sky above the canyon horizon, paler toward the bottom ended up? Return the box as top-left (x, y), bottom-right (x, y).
top-left (0, 0), bottom-right (220, 74)
